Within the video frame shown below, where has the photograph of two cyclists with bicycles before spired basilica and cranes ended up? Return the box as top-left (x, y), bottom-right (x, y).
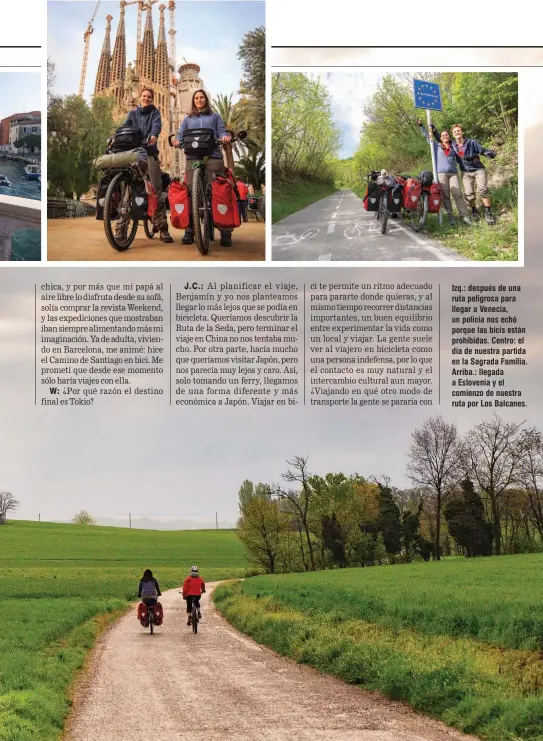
top-left (47, 0), bottom-right (265, 262)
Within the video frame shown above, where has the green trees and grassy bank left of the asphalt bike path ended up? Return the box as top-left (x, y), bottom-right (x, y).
top-left (272, 72), bottom-right (341, 223)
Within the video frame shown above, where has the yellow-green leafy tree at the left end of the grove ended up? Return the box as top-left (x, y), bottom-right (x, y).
top-left (237, 496), bottom-right (289, 574)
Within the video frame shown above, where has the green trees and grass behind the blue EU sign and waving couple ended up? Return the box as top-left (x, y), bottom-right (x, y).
top-left (335, 72), bottom-right (518, 261)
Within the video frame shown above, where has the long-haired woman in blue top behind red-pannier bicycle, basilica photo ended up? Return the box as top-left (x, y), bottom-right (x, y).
top-left (172, 90), bottom-right (232, 247)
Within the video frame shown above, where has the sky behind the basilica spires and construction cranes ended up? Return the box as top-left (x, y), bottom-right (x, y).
top-left (47, 0), bottom-right (265, 100)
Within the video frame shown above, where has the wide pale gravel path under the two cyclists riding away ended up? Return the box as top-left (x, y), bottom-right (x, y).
top-left (65, 585), bottom-right (480, 741)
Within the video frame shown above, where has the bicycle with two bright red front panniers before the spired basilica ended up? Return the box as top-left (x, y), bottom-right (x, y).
top-left (168, 128), bottom-right (247, 255)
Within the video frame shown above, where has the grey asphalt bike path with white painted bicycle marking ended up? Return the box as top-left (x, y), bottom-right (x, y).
top-left (272, 190), bottom-right (465, 262)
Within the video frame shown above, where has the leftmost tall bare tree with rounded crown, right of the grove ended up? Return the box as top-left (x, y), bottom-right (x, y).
top-left (407, 416), bottom-right (463, 561)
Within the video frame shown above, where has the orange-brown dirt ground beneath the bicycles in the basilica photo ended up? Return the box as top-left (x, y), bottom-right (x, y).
top-left (47, 216), bottom-right (266, 263)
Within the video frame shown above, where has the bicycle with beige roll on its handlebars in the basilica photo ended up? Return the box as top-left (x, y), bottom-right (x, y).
top-left (94, 126), bottom-right (158, 252)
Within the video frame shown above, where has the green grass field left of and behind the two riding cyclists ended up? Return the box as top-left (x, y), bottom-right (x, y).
top-left (0, 522), bottom-right (246, 741)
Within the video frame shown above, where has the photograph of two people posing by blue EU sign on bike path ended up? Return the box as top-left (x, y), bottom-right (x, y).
top-left (272, 68), bottom-right (519, 263)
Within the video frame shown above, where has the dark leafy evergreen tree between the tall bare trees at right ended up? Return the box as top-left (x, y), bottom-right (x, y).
top-left (444, 478), bottom-right (492, 558)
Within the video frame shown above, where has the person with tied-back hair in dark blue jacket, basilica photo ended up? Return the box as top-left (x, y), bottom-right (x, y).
top-left (123, 87), bottom-right (173, 242)
